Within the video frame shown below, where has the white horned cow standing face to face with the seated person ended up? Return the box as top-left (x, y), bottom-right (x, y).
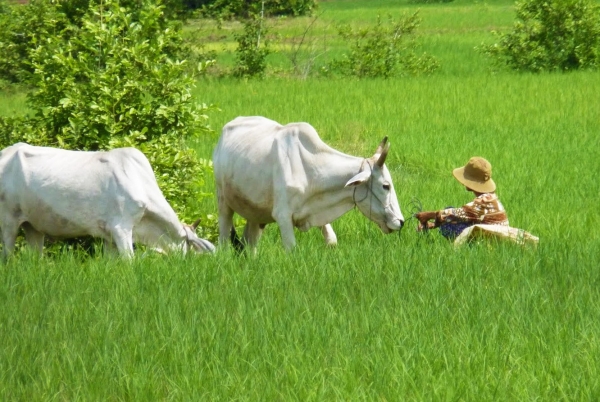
top-left (213, 116), bottom-right (404, 250)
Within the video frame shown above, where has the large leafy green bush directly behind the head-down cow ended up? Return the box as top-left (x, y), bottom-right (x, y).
top-left (0, 0), bottom-right (216, 236)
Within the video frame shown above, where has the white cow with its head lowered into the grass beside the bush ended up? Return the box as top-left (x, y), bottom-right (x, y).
top-left (0, 143), bottom-right (215, 257)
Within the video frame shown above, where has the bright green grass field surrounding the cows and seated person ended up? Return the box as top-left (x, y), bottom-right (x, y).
top-left (0, 0), bottom-right (600, 401)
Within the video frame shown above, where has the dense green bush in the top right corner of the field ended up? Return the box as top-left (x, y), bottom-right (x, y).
top-left (480, 0), bottom-right (600, 72)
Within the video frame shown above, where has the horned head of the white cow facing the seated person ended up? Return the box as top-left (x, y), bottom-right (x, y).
top-left (346, 137), bottom-right (404, 233)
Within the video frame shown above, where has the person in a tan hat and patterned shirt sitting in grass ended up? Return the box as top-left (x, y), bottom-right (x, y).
top-left (415, 156), bottom-right (508, 240)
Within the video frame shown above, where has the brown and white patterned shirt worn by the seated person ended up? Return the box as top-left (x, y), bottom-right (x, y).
top-left (437, 193), bottom-right (509, 226)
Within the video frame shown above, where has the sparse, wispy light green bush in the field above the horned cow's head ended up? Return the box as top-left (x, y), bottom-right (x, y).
top-left (325, 12), bottom-right (439, 78)
